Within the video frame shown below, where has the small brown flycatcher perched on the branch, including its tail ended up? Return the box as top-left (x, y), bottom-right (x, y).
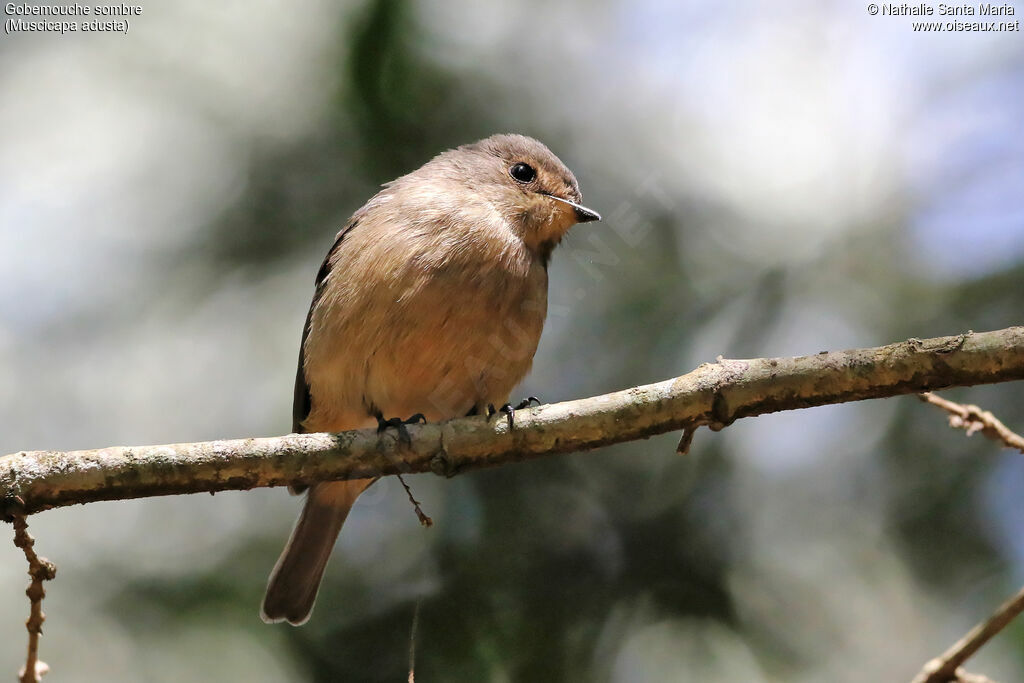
top-left (261, 135), bottom-right (601, 626)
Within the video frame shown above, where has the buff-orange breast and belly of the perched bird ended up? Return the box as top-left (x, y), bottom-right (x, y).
top-left (305, 227), bottom-right (548, 428)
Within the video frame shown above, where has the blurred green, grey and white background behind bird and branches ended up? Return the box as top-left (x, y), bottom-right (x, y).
top-left (0, 0), bottom-right (1024, 683)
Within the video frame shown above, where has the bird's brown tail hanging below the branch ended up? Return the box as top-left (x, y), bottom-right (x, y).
top-left (260, 479), bottom-right (375, 626)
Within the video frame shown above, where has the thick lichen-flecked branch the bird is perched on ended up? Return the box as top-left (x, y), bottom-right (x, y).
top-left (0, 328), bottom-right (1024, 513)
